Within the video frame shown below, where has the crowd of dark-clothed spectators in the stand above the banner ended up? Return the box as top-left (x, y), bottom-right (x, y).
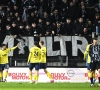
top-left (0, 0), bottom-right (100, 37)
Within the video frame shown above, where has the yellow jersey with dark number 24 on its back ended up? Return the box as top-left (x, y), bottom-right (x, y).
top-left (28, 47), bottom-right (41, 63)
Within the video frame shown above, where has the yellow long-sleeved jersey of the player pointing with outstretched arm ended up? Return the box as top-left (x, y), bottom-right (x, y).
top-left (0, 46), bottom-right (17, 64)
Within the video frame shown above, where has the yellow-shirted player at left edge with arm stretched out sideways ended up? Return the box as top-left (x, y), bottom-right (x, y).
top-left (0, 44), bottom-right (19, 81)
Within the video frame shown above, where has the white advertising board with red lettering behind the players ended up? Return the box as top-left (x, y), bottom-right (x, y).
top-left (7, 68), bottom-right (98, 82)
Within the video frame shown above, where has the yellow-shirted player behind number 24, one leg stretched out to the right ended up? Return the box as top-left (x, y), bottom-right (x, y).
top-left (39, 41), bottom-right (54, 83)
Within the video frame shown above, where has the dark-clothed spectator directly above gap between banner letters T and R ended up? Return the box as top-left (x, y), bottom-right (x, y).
top-left (63, 18), bottom-right (73, 35)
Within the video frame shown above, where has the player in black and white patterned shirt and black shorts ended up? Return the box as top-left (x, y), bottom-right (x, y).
top-left (89, 38), bottom-right (100, 86)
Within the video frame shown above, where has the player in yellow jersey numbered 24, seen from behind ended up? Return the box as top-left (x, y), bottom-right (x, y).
top-left (27, 41), bottom-right (41, 84)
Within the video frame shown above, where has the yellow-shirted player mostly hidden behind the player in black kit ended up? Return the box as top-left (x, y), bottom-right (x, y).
top-left (84, 44), bottom-right (96, 83)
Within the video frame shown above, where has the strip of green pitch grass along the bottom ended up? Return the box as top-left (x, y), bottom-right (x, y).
top-left (0, 82), bottom-right (100, 90)
